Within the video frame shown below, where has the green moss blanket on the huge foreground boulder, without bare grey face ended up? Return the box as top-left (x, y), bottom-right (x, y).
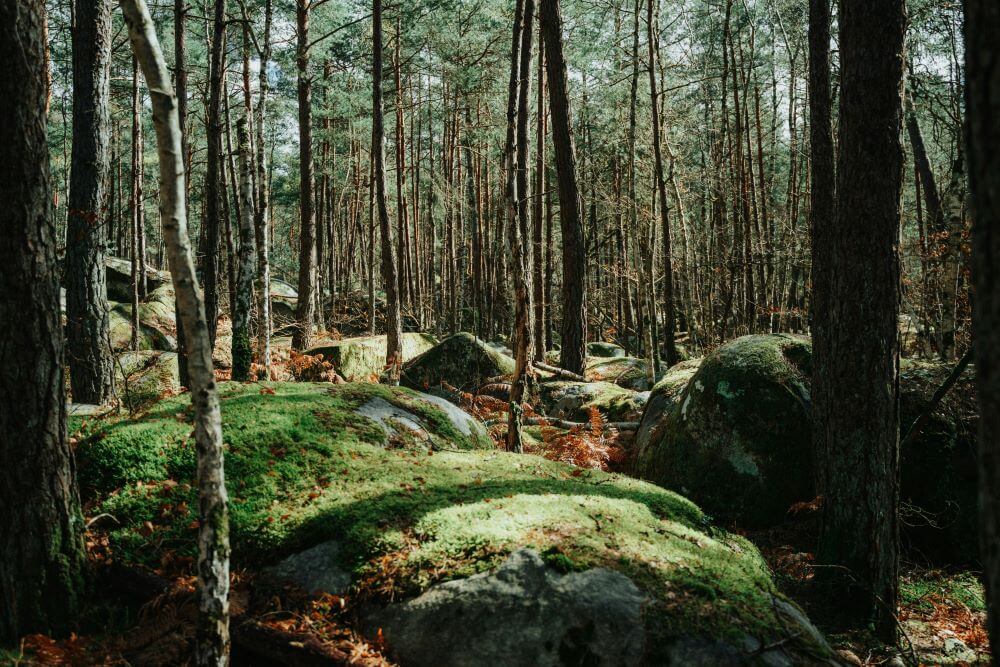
top-left (77, 383), bottom-right (831, 664)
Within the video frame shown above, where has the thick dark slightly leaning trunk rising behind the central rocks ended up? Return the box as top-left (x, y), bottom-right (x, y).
top-left (539, 0), bottom-right (587, 375)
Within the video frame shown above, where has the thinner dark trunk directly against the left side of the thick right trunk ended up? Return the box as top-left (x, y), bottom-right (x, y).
top-left (809, 0), bottom-right (837, 494)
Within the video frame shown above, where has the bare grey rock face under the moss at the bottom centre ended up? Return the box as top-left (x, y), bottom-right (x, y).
top-left (367, 549), bottom-right (645, 667)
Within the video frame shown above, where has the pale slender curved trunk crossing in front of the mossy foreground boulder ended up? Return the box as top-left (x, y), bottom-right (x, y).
top-left (119, 0), bottom-right (230, 666)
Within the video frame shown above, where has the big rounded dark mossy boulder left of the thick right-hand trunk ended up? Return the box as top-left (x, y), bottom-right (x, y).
top-left (632, 334), bottom-right (813, 526)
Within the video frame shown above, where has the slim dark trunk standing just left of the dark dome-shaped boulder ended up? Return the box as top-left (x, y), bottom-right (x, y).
top-left (372, 0), bottom-right (403, 385)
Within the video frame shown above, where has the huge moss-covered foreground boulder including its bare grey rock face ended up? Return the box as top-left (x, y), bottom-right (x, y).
top-left (77, 383), bottom-right (834, 666)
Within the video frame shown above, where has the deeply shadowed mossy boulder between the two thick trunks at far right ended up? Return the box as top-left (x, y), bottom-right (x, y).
top-left (899, 360), bottom-right (979, 562)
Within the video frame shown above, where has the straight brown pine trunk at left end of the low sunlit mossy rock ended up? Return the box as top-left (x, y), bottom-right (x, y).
top-left (292, 0), bottom-right (316, 350)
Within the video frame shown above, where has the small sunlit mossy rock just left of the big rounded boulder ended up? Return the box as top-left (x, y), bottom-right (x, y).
top-left (539, 381), bottom-right (645, 422)
